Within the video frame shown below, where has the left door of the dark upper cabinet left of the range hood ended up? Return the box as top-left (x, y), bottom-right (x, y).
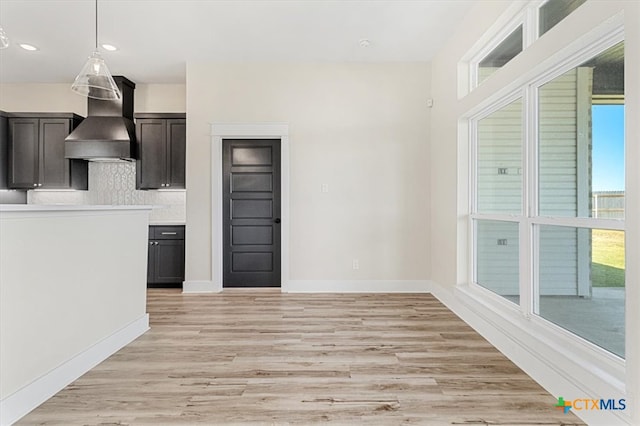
top-left (9, 118), bottom-right (39, 189)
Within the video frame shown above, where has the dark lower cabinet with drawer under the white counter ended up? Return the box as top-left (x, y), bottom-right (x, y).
top-left (147, 226), bottom-right (184, 288)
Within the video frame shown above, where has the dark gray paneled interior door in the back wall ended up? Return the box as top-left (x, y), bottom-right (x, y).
top-left (222, 139), bottom-right (280, 287)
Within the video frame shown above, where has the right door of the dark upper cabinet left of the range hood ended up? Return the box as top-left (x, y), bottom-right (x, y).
top-left (39, 118), bottom-right (71, 188)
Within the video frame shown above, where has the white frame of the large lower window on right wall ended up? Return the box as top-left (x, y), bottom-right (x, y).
top-left (468, 30), bottom-right (625, 354)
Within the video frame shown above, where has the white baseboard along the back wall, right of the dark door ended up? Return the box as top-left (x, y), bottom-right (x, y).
top-left (282, 280), bottom-right (431, 293)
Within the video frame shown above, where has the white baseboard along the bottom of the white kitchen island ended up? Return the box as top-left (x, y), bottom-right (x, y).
top-left (0, 314), bottom-right (149, 425)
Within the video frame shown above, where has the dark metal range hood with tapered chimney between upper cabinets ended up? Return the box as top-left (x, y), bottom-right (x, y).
top-left (64, 76), bottom-right (136, 161)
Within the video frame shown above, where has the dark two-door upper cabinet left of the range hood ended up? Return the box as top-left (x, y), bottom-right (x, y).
top-left (8, 113), bottom-right (88, 189)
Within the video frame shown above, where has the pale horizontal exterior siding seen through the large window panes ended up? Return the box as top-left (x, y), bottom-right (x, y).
top-left (476, 68), bottom-right (591, 296)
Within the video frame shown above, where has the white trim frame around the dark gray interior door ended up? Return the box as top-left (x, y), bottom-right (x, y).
top-left (211, 123), bottom-right (289, 291)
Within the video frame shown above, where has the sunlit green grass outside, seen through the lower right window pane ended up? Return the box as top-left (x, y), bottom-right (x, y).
top-left (591, 229), bottom-right (625, 287)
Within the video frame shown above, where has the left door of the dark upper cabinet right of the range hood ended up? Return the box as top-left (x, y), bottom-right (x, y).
top-left (136, 119), bottom-right (167, 189)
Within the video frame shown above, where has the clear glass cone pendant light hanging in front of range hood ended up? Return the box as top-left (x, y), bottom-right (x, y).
top-left (71, 0), bottom-right (122, 100)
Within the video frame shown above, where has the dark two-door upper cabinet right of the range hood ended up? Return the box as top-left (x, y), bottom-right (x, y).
top-left (134, 113), bottom-right (187, 189)
